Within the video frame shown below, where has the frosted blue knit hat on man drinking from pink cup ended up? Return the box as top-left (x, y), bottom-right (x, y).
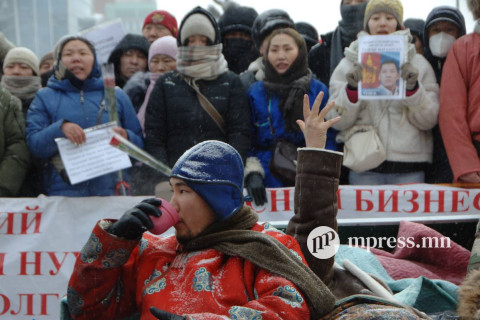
top-left (171, 140), bottom-right (244, 220)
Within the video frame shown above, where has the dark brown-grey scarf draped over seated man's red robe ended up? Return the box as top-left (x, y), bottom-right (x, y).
top-left (183, 206), bottom-right (335, 319)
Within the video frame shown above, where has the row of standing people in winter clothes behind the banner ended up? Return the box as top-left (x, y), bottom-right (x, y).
top-left (0, 0), bottom-right (480, 202)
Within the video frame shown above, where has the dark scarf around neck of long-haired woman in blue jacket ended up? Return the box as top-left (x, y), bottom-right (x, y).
top-left (263, 46), bottom-right (312, 131)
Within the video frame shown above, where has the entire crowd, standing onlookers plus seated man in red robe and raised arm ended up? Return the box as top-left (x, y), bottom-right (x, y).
top-left (0, 0), bottom-right (480, 320)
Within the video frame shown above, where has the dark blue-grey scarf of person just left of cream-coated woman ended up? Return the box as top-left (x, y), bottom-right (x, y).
top-left (330, 2), bottom-right (367, 76)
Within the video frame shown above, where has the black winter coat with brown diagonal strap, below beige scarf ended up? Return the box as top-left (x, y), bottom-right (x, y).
top-left (145, 71), bottom-right (251, 172)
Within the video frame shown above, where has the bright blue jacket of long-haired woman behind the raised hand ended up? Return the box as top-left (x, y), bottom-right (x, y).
top-left (248, 79), bottom-right (337, 188)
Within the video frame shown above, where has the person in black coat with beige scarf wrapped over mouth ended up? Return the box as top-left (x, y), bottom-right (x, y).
top-left (145, 7), bottom-right (250, 194)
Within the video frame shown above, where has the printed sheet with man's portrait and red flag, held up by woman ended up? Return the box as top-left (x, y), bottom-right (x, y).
top-left (358, 35), bottom-right (407, 100)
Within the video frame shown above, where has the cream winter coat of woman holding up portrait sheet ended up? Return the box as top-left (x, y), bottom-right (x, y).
top-left (327, 30), bottom-right (439, 162)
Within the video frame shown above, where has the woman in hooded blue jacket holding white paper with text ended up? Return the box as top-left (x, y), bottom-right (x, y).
top-left (27, 36), bottom-right (143, 197)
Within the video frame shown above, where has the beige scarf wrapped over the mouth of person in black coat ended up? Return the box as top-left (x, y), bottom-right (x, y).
top-left (177, 43), bottom-right (228, 80)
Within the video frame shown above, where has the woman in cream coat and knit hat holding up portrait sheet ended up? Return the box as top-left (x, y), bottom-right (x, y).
top-left (327, 0), bottom-right (439, 185)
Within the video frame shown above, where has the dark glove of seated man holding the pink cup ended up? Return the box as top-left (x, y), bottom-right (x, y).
top-left (107, 198), bottom-right (162, 240)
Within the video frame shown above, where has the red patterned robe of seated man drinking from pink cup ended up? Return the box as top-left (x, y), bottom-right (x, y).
top-left (68, 224), bottom-right (310, 320)
